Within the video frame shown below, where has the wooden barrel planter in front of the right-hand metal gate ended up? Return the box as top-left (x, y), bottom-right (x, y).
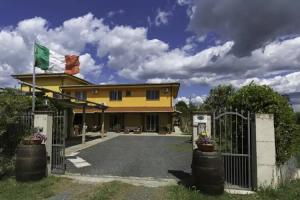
top-left (192, 149), bottom-right (224, 195)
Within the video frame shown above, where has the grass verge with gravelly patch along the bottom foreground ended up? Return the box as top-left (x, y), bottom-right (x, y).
top-left (0, 176), bottom-right (300, 200)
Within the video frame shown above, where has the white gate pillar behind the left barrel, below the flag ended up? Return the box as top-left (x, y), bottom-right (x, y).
top-left (33, 112), bottom-right (53, 174)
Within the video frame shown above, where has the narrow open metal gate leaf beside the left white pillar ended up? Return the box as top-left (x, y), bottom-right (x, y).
top-left (51, 110), bottom-right (67, 174)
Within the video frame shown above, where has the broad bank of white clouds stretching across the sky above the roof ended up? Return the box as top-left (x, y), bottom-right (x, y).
top-left (0, 14), bottom-right (300, 98)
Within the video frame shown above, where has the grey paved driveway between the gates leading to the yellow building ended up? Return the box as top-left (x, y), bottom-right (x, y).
top-left (67, 136), bottom-right (192, 178)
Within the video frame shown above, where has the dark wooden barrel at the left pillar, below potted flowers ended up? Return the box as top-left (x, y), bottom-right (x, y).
top-left (16, 144), bottom-right (47, 181)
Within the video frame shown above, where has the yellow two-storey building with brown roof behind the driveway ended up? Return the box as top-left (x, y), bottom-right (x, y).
top-left (13, 74), bottom-right (180, 132)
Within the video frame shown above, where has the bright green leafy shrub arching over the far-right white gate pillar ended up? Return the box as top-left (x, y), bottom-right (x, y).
top-left (231, 83), bottom-right (297, 164)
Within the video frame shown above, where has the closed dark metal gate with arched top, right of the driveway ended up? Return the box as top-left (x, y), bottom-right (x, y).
top-left (212, 110), bottom-right (252, 190)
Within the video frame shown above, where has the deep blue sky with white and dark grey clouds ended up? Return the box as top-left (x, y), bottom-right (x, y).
top-left (0, 0), bottom-right (300, 108)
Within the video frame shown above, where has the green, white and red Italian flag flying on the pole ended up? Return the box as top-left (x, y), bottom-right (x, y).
top-left (34, 44), bottom-right (80, 75)
